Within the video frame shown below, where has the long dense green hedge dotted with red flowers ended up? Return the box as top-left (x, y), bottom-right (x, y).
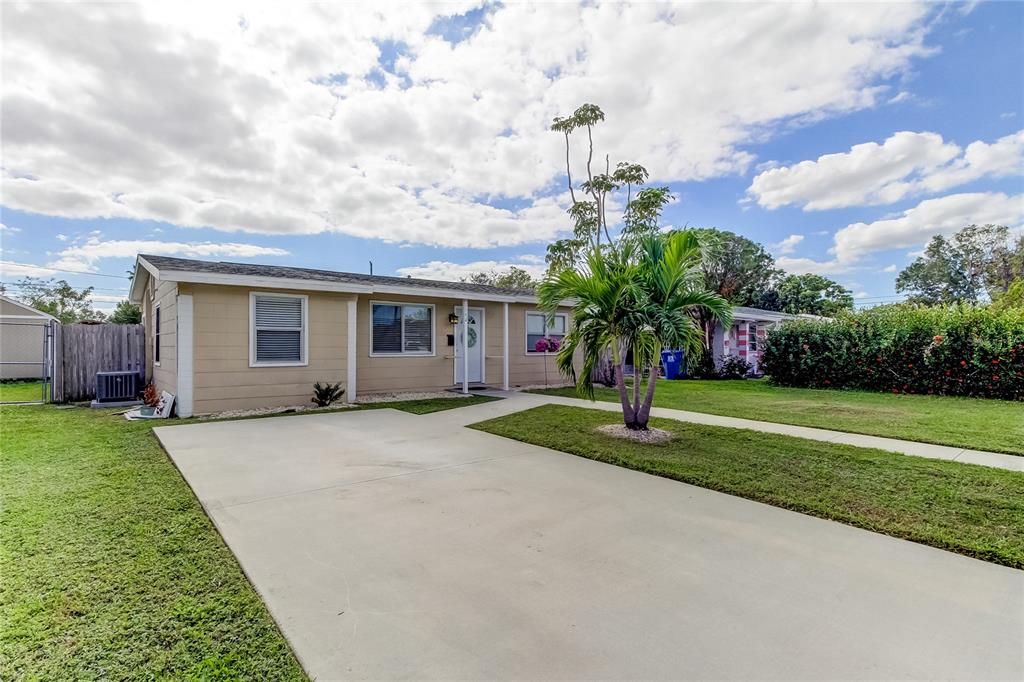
top-left (761, 305), bottom-right (1024, 400)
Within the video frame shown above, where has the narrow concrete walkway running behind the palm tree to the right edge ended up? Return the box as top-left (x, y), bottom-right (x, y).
top-left (434, 391), bottom-right (1024, 471)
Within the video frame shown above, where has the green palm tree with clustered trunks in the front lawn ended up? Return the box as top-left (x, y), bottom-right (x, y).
top-left (538, 230), bottom-right (732, 430)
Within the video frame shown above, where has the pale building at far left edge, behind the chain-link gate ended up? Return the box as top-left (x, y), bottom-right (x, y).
top-left (0, 295), bottom-right (56, 379)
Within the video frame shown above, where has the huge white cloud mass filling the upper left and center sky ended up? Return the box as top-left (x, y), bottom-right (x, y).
top-left (2, 2), bottom-right (936, 247)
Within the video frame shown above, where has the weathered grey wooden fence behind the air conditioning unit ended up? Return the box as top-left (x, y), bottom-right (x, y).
top-left (52, 325), bottom-right (145, 402)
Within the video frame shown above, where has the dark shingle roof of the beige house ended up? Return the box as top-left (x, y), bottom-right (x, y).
top-left (139, 254), bottom-right (535, 296)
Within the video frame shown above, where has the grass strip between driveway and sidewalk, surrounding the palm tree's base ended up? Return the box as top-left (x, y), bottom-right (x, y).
top-left (472, 406), bottom-right (1024, 568)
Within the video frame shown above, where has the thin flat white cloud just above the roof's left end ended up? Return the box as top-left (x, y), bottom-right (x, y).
top-left (49, 237), bottom-right (288, 271)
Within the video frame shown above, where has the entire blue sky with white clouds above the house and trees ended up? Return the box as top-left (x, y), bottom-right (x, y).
top-left (0, 1), bottom-right (1024, 309)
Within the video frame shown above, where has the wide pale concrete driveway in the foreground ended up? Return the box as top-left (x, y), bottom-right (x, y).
top-left (156, 403), bottom-right (1024, 679)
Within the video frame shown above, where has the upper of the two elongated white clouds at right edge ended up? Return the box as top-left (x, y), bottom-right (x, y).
top-left (748, 130), bottom-right (1024, 211)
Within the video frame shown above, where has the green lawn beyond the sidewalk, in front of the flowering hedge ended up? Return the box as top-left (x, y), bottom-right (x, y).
top-left (536, 380), bottom-right (1024, 455)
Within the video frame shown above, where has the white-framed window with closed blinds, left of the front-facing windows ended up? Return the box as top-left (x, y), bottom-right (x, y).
top-left (250, 294), bottom-right (307, 366)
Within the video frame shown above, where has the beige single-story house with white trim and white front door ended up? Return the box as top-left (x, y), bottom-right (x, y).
top-left (129, 255), bottom-right (570, 417)
